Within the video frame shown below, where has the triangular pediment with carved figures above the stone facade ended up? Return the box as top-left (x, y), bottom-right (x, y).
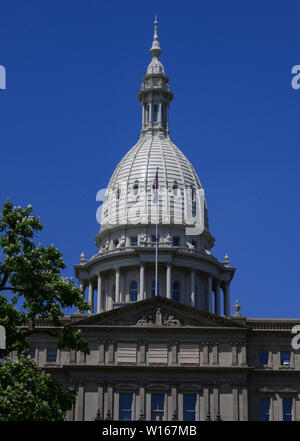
top-left (69, 296), bottom-right (247, 329)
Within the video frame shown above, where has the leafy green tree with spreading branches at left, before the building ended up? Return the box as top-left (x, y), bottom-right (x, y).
top-left (0, 201), bottom-right (90, 419)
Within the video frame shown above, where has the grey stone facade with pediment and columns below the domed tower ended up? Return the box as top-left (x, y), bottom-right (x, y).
top-left (15, 296), bottom-right (300, 421)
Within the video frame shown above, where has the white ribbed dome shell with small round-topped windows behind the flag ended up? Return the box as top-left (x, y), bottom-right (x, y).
top-left (101, 133), bottom-right (208, 231)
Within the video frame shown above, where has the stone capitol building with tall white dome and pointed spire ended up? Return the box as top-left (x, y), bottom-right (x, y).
top-left (22, 20), bottom-right (300, 421)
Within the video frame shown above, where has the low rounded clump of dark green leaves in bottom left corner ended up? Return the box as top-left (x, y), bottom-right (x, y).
top-left (0, 360), bottom-right (76, 421)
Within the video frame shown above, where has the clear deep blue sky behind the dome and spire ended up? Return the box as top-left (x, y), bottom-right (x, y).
top-left (0, 0), bottom-right (300, 317)
